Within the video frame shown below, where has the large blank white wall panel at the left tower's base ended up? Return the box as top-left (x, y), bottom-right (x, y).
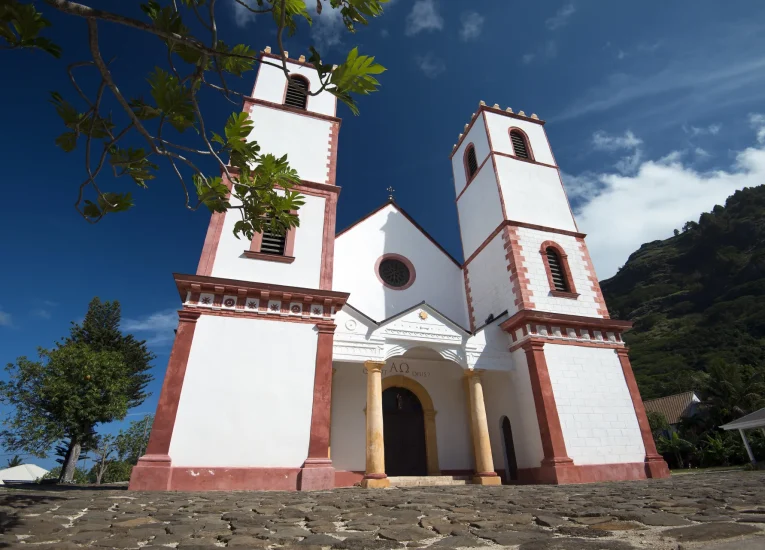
top-left (170, 315), bottom-right (317, 468)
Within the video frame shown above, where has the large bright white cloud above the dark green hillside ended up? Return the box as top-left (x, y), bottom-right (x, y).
top-left (564, 114), bottom-right (765, 279)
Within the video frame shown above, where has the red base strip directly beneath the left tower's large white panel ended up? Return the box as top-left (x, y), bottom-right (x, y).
top-left (168, 466), bottom-right (300, 491)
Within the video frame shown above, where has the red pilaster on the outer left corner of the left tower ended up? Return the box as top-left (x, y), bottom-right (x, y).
top-left (130, 309), bottom-right (199, 491)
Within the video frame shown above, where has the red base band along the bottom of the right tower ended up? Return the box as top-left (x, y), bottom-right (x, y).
top-left (518, 462), bottom-right (648, 485)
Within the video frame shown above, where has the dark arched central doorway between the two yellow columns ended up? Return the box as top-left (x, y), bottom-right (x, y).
top-left (382, 386), bottom-right (428, 476)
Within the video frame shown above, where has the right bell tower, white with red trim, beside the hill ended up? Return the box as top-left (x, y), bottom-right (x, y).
top-left (451, 102), bottom-right (669, 483)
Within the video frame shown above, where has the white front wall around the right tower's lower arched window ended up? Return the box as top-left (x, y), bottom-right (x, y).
top-left (517, 227), bottom-right (602, 317)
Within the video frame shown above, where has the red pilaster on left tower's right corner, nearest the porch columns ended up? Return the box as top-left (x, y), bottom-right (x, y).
top-left (298, 323), bottom-right (336, 491)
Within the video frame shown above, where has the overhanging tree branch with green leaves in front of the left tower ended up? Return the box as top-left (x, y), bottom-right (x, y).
top-left (0, 0), bottom-right (388, 239)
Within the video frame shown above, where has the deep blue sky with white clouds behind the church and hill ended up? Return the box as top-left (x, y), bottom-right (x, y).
top-left (0, 0), bottom-right (765, 465)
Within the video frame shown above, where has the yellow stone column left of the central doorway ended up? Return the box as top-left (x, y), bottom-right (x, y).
top-left (361, 361), bottom-right (390, 489)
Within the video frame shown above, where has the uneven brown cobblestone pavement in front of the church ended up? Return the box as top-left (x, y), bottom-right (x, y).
top-left (0, 472), bottom-right (765, 550)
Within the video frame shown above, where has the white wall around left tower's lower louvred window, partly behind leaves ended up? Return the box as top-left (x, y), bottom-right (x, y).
top-left (211, 195), bottom-right (325, 288)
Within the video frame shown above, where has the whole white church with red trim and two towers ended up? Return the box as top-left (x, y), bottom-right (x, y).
top-left (130, 49), bottom-right (669, 491)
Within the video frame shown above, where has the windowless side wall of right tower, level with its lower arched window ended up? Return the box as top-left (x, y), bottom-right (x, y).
top-left (467, 233), bottom-right (518, 327)
